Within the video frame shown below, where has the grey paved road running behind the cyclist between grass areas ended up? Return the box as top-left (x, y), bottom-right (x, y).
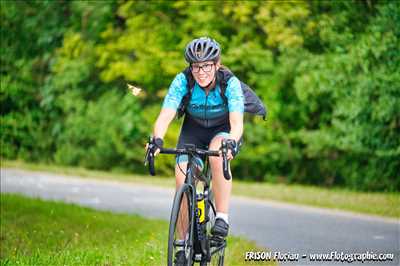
top-left (1, 169), bottom-right (400, 265)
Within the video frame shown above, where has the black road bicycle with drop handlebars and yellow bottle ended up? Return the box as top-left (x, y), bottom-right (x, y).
top-left (145, 139), bottom-right (231, 266)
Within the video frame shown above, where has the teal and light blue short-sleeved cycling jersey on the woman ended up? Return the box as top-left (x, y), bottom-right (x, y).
top-left (163, 73), bottom-right (244, 119)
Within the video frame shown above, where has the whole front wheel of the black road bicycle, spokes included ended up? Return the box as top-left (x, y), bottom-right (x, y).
top-left (168, 184), bottom-right (194, 266)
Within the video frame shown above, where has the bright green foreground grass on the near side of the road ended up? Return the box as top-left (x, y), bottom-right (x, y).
top-left (0, 194), bottom-right (276, 266)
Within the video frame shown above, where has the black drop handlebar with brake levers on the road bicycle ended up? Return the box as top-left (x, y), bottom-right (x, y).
top-left (144, 137), bottom-right (232, 180)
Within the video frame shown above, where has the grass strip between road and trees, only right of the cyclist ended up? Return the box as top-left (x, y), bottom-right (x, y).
top-left (233, 182), bottom-right (400, 218)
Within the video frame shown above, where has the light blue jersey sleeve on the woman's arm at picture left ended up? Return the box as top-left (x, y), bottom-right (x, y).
top-left (162, 73), bottom-right (187, 111)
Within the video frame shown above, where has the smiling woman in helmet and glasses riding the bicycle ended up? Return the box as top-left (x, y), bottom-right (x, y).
top-left (148, 37), bottom-right (244, 261)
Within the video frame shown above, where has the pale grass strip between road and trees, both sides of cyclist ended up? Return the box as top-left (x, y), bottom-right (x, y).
top-left (2, 161), bottom-right (400, 218)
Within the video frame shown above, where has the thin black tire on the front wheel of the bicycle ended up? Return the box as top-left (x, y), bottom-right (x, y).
top-left (168, 184), bottom-right (195, 266)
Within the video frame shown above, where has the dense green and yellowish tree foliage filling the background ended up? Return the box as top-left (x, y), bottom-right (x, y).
top-left (0, 0), bottom-right (400, 191)
